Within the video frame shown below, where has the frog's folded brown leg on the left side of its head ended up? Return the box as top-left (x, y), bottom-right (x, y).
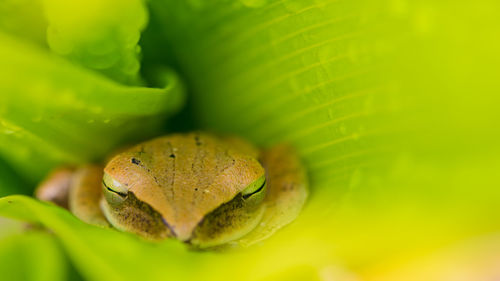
top-left (35, 165), bottom-right (109, 226)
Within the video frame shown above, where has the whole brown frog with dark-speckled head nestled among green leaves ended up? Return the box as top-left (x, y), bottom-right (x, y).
top-left (35, 131), bottom-right (308, 249)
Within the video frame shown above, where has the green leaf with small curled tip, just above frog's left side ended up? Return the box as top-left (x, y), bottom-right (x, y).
top-left (0, 34), bottom-right (184, 181)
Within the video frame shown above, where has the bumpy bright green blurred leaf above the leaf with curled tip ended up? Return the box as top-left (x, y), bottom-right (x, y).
top-left (42, 0), bottom-right (147, 84)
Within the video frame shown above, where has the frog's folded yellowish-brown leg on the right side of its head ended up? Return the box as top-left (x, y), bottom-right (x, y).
top-left (236, 144), bottom-right (308, 246)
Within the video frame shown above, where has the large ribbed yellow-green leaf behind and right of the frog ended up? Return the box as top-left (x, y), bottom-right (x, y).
top-left (146, 0), bottom-right (500, 274)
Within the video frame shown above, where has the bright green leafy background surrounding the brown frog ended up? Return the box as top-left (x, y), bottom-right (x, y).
top-left (0, 0), bottom-right (500, 280)
